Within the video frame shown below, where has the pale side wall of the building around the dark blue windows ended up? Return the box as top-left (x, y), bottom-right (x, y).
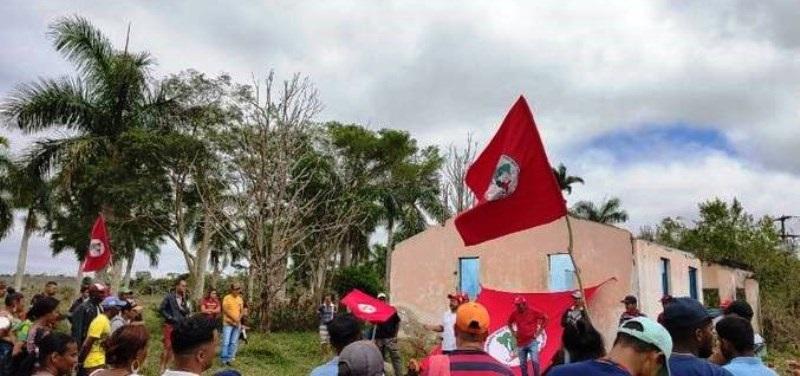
top-left (634, 239), bottom-right (703, 317)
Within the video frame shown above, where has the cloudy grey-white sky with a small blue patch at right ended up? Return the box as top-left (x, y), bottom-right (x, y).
top-left (0, 0), bottom-right (800, 274)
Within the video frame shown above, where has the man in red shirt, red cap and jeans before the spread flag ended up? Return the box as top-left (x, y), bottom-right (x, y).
top-left (507, 296), bottom-right (548, 376)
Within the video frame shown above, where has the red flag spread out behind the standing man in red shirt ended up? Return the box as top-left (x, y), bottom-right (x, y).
top-left (477, 281), bottom-right (607, 375)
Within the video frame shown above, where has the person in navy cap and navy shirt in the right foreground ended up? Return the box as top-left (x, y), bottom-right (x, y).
top-left (662, 297), bottom-right (730, 376)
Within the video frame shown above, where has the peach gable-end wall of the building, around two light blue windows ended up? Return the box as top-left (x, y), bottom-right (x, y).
top-left (391, 219), bottom-right (635, 344)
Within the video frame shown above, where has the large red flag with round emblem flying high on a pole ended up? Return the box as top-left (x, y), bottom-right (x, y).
top-left (455, 96), bottom-right (567, 246)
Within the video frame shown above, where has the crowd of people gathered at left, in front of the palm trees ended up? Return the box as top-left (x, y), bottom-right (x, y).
top-left (0, 279), bottom-right (247, 376)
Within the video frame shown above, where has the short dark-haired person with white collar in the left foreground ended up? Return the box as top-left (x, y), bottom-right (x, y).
top-left (161, 314), bottom-right (219, 376)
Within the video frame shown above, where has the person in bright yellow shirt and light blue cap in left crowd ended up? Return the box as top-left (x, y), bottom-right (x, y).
top-left (79, 296), bottom-right (125, 375)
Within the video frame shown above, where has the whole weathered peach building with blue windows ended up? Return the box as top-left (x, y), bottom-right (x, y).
top-left (391, 218), bottom-right (758, 338)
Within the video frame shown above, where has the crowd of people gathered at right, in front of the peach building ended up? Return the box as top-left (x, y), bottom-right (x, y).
top-left (311, 292), bottom-right (777, 376)
